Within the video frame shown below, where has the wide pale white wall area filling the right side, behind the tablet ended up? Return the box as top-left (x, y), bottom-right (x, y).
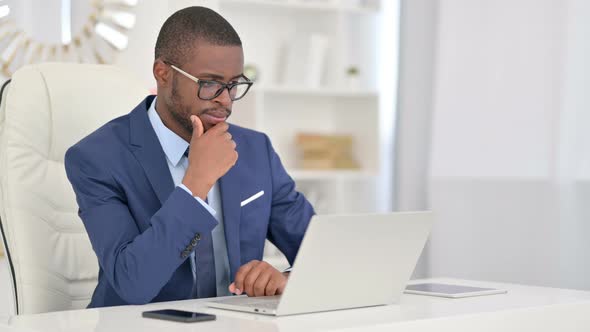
top-left (429, 0), bottom-right (590, 289)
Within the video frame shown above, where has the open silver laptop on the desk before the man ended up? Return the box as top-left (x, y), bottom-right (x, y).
top-left (206, 211), bottom-right (432, 316)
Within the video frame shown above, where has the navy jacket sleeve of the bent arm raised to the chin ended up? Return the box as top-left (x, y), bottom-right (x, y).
top-left (65, 146), bottom-right (217, 304)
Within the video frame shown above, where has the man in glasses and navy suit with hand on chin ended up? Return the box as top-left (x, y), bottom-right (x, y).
top-left (65, 7), bottom-right (314, 307)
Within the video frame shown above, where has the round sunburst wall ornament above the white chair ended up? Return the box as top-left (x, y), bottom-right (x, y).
top-left (0, 0), bottom-right (138, 77)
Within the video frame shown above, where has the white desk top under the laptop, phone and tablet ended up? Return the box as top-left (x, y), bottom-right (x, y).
top-left (0, 279), bottom-right (590, 332)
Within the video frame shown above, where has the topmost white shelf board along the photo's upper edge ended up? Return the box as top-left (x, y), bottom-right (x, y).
top-left (220, 0), bottom-right (378, 14)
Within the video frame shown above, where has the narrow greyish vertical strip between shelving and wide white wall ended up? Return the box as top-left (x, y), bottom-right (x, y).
top-left (393, 0), bottom-right (438, 278)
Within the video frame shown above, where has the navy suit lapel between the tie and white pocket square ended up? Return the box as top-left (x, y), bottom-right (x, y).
top-left (219, 126), bottom-right (242, 282)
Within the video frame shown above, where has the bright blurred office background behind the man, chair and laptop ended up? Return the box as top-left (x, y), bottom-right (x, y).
top-left (0, 0), bottom-right (590, 320)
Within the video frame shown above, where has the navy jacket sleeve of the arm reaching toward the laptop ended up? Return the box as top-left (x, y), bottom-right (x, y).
top-left (265, 136), bottom-right (315, 265)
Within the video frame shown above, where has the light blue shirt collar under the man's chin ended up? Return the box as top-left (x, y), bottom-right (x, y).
top-left (148, 97), bottom-right (189, 167)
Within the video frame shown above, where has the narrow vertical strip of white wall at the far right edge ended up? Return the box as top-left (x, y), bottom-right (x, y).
top-left (556, 0), bottom-right (590, 289)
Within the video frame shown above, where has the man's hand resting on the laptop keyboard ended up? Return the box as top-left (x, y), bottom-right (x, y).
top-left (229, 260), bottom-right (287, 296)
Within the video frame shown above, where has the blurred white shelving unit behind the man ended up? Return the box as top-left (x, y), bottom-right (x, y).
top-left (169, 0), bottom-right (397, 267)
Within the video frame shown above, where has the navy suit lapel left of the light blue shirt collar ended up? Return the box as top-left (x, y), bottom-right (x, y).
top-left (129, 96), bottom-right (174, 204)
